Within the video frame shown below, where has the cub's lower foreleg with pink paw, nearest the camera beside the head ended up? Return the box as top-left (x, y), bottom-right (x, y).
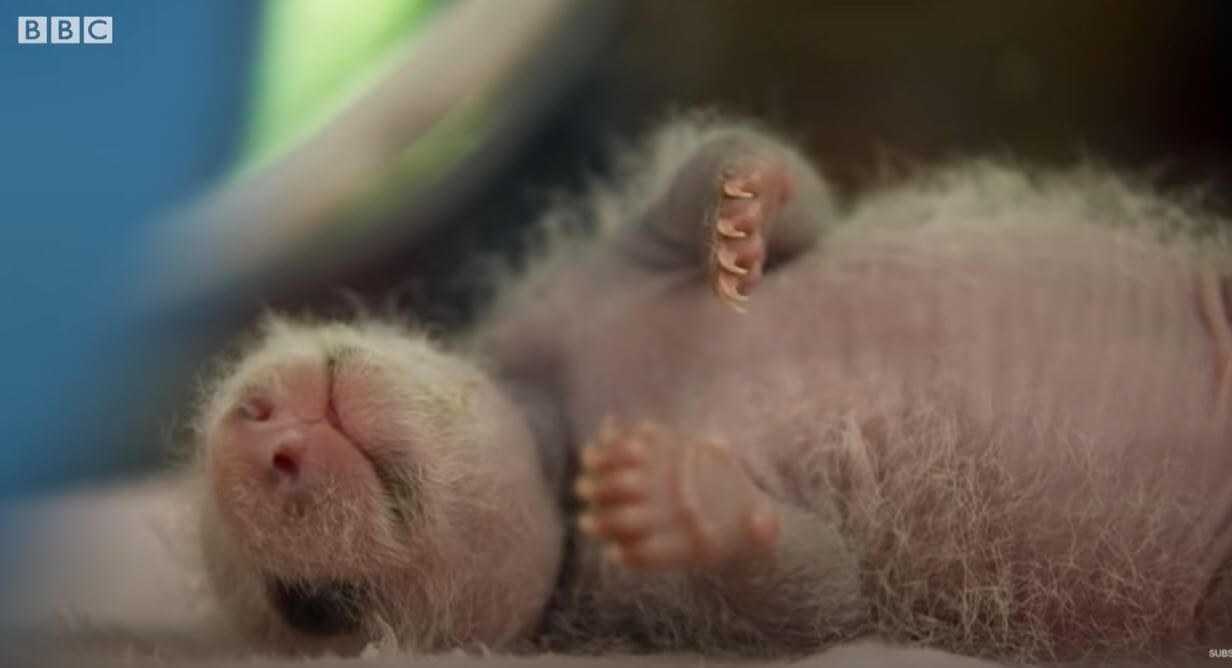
top-left (575, 424), bottom-right (867, 653)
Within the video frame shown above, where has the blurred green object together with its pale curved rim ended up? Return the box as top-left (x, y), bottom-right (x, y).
top-left (146, 0), bottom-right (614, 311)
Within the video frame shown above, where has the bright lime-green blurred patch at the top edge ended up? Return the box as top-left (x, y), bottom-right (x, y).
top-left (239, 0), bottom-right (445, 169)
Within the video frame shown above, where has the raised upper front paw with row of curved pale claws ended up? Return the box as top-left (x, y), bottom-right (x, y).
top-left (708, 158), bottom-right (793, 313)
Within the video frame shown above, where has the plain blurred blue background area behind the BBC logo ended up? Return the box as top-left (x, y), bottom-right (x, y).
top-left (0, 0), bottom-right (259, 492)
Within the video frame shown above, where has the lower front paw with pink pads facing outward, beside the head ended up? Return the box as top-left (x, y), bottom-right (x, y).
top-left (574, 423), bottom-right (779, 569)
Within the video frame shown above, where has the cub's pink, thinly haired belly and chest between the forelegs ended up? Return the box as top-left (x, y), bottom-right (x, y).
top-left (568, 226), bottom-right (1232, 621)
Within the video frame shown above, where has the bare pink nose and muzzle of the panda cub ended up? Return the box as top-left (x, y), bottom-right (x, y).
top-left (205, 360), bottom-right (386, 578)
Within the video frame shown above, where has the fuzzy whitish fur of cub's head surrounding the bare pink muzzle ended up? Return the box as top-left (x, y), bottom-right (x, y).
top-left (197, 317), bottom-right (559, 652)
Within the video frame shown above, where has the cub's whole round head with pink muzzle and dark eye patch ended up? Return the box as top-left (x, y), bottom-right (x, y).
top-left (197, 319), bottom-right (562, 651)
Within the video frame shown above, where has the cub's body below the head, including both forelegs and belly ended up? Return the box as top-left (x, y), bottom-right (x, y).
top-left (477, 123), bottom-right (1232, 663)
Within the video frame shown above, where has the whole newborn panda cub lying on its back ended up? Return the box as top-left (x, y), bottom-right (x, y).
top-left (198, 121), bottom-right (1232, 662)
